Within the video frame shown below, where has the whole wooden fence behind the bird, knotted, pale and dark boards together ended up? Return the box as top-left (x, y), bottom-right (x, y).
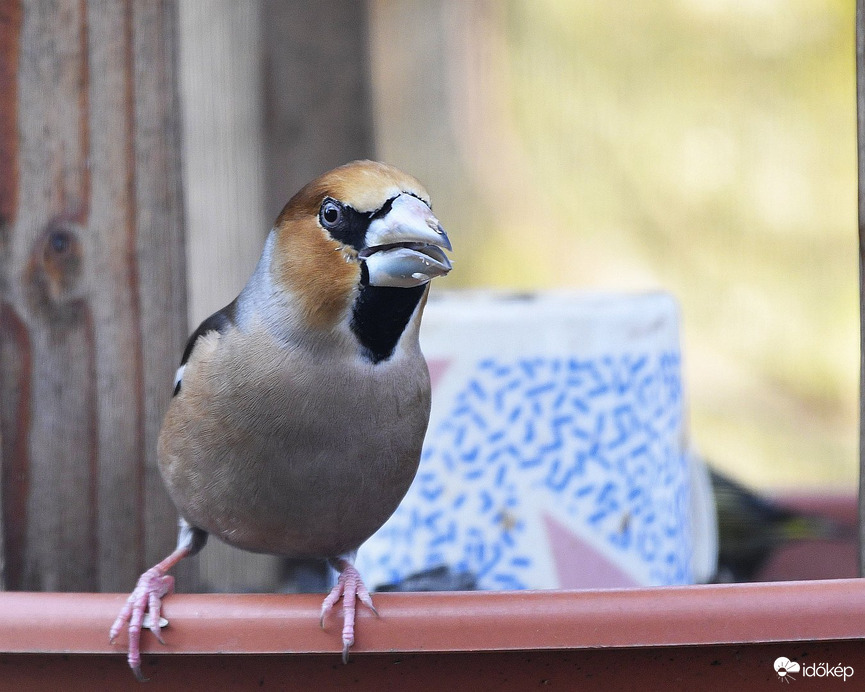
top-left (0, 0), bottom-right (373, 591)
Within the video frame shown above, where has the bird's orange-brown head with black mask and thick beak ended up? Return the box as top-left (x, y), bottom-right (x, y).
top-left (271, 161), bottom-right (451, 356)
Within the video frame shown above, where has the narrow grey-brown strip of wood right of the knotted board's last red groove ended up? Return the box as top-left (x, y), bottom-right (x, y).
top-left (126, 0), bottom-right (187, 588)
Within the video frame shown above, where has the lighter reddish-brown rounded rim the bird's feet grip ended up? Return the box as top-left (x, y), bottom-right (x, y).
top-left (0, 579), bottom-right (865, 656)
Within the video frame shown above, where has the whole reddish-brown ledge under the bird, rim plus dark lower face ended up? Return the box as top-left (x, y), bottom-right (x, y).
top-left (0, 579), bottom-right (865, 692)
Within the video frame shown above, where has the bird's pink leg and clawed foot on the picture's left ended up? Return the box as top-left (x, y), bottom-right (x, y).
top-left (108, 546), bottom-right (191, 682)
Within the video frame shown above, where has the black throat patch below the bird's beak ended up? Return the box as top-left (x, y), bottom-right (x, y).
top-left (351, 284), bottom-right (426, 363)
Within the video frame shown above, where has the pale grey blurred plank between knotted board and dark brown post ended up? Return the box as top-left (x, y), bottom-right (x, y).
top-left (176, 0), bottom-right (279, 591)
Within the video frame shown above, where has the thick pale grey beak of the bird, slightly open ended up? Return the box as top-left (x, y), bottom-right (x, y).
top-left (360, 194), bottom-right (452, 288)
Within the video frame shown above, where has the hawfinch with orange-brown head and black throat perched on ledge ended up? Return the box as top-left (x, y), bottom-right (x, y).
top-left (109, 160), bottom-right (452, 680)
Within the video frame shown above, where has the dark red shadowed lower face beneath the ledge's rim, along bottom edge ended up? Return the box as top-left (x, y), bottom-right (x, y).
top-left (0, 641), bottom-right (865, 692)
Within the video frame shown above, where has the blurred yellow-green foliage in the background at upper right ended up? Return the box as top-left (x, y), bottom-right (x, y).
top-left (480, 0), bottom-right (859, 490)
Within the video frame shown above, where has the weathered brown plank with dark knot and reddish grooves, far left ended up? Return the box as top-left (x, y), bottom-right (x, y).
top-left (0, 0), bottom-right (186, 590)
